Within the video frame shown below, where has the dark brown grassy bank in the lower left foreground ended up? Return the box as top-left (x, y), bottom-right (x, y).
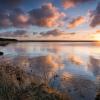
top-left (0, 62), bottom-right (70, 100)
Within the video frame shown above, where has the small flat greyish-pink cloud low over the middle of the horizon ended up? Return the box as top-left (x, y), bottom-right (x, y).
top-left (40, 29), bottom-right (64, 37)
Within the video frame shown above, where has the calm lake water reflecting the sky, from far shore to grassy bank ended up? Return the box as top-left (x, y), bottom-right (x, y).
top-left (0, 42), bottom-right (100, 100)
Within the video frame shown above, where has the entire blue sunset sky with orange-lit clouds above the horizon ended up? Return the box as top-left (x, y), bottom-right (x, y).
top-left (0, 0), bottom-right (100, 40)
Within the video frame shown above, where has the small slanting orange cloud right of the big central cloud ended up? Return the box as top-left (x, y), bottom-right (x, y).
top-left (67, 16), bottom-right (86, 28)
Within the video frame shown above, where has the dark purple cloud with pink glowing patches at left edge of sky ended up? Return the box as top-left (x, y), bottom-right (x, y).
top-left (0, 8), bottom-right (30, 28)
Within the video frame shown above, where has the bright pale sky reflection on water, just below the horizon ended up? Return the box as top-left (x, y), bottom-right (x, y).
top-left (1, 43), bottom-right (100, 76)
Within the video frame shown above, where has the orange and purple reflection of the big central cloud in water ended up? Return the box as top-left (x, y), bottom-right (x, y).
top-left (13, 55), bottom-right (64, 81)
